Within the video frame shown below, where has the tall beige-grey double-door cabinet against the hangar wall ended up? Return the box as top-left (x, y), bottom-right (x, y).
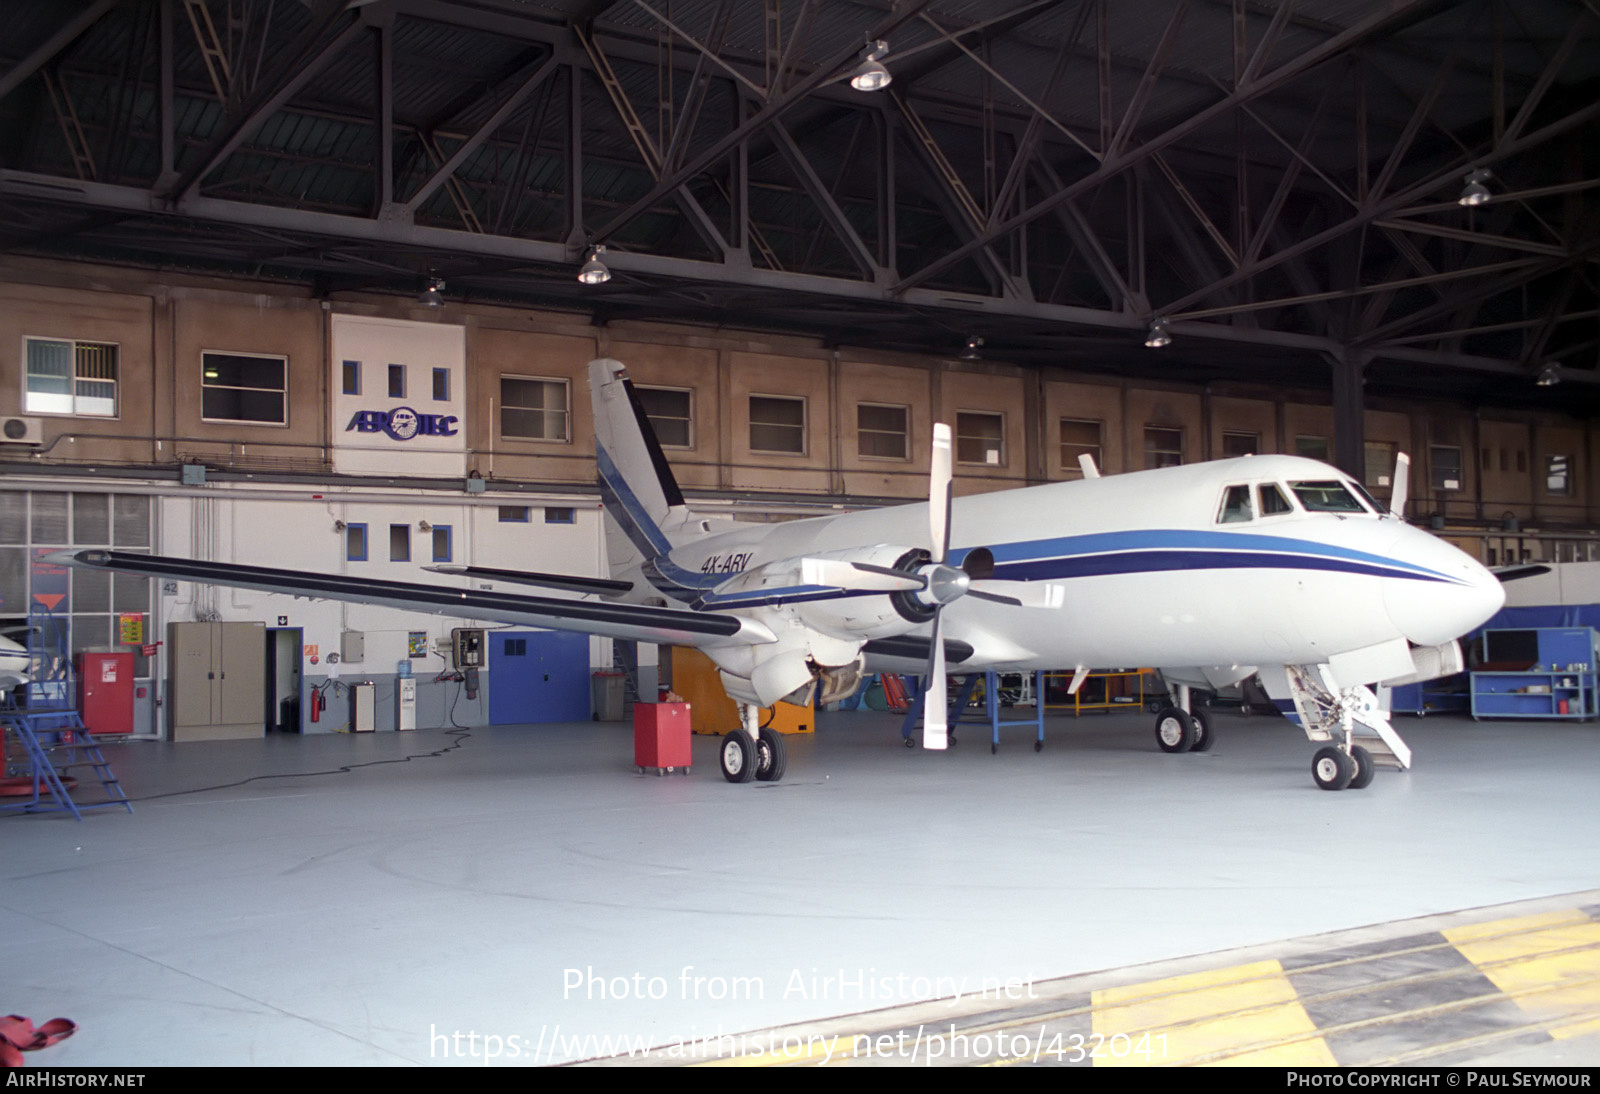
top-left (166, 622), bottom-right (267, 741)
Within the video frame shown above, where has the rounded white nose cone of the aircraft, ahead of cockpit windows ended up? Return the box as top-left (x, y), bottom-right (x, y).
top-left (1384, 528), bottom-right (1506, 646)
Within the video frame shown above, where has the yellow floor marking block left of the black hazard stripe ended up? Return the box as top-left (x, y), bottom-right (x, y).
top-left (1093, 961), bottom-right (1336, 1067)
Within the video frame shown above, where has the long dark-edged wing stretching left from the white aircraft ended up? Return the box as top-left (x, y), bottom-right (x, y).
top-left (50, 550), bottom-right (773, 646)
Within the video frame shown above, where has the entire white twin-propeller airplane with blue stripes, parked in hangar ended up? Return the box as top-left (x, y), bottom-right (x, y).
top-left (59, 360), bottom-right (1504, 790)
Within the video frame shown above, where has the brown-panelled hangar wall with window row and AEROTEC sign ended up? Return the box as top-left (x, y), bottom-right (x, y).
top-left (0, 256), bottom-right (1600, 726)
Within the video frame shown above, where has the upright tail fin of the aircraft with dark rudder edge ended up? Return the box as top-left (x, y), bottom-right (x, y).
top-left (589, 357), bottom-right (688, 560)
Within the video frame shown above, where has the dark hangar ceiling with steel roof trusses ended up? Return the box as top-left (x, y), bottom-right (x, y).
top-left (0, 0), bottom-right (1600, 413)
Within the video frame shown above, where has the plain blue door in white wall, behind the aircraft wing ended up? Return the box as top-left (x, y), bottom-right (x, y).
top-left (490, 630), bottom-right (589, 726)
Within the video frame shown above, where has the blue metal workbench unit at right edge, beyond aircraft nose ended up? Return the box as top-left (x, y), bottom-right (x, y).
top-left (1472, 627), bottom-right (1600, 718)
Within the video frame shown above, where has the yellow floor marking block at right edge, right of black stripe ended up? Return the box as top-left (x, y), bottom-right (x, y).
top-left (1443, 908), bottom-right (1600, 1038)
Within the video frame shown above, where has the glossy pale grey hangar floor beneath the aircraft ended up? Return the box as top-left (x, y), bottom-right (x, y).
top-left (0, 703), bottom-right (1600, 1067)
